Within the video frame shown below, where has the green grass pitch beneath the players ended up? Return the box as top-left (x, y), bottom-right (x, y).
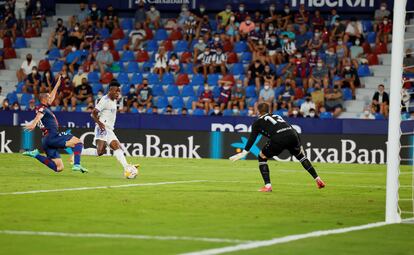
top-left (0, 154), bottom-right (414, 255)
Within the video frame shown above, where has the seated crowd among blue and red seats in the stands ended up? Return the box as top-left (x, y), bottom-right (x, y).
top-left (0, 0), bottom-right (414, 118)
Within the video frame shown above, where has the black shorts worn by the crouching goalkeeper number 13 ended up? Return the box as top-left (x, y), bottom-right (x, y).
top-left (262, 129), bottom-right (302, 158)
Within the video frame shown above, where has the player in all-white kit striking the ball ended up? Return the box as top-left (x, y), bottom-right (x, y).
top-left (92, 80), bottom-right (139, 177)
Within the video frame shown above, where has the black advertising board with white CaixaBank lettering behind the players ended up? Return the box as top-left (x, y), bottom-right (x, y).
top-left (0, 126), bottom-right (408, 164)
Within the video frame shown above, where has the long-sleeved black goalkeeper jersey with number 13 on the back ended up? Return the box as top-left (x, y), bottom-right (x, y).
top-left (244, 114), bottom-right (293, 151)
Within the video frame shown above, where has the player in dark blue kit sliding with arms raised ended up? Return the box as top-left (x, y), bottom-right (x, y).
top-left (23, 76), bottom-right (88, 173)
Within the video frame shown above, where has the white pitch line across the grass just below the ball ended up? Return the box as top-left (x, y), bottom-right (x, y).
top-left (0, 180), bottom-right (207, 195)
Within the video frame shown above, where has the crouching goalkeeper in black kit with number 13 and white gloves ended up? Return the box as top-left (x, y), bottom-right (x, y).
top-left (230, 103), bottom-right (325, 192)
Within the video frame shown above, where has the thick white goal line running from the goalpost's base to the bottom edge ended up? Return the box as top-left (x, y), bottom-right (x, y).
top-left (181, 222), bottom-right (387, 255)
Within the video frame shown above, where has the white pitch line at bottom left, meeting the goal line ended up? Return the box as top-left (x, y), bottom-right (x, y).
top-left (0, 230), bottom-right (254, 243)
